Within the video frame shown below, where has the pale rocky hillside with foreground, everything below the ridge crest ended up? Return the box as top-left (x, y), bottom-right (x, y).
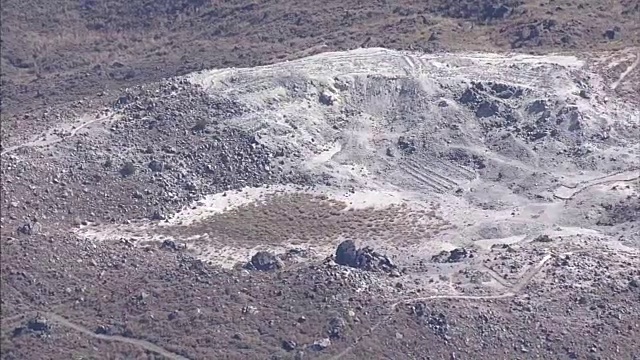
top-left (2, 48), bottom-right (640, 359)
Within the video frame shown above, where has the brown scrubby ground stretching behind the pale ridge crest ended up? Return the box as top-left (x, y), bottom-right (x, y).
top-left (2, 0), bottom-right (640, 119)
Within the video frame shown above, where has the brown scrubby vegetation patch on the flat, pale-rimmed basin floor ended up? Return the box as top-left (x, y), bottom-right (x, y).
top-left (151, 194), bottom-right (443, 247)
